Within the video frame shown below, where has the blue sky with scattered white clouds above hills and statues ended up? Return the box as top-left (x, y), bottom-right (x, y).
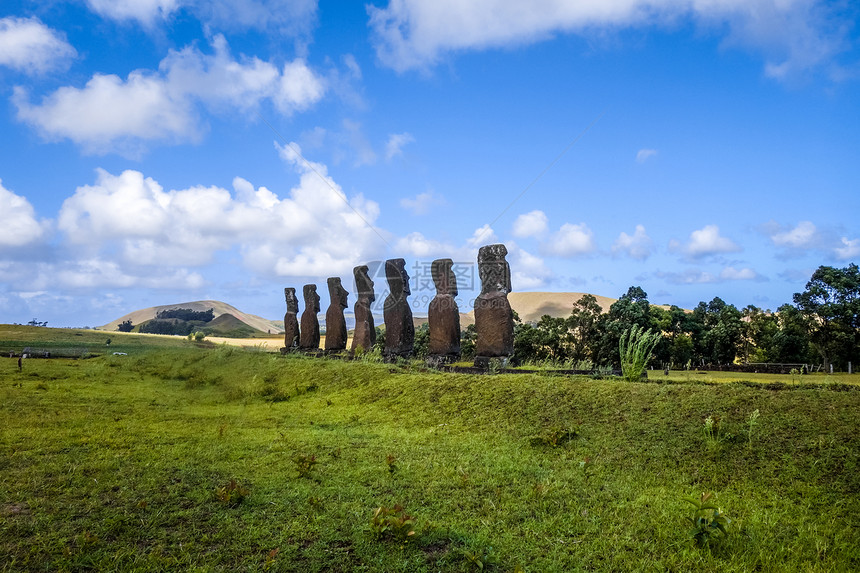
top-left (0, 0), bottom-right (860, 326)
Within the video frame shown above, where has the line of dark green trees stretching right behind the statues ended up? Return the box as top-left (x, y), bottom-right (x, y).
top-left (470, 264), bottom-right (860, 370)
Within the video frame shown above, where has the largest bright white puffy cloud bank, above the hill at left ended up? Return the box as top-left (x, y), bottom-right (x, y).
top-left (57, 144), bottom-right (382, 286)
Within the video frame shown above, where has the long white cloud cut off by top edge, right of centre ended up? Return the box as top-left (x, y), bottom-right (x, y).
top-left (368, 0), bottom-right (848, 77)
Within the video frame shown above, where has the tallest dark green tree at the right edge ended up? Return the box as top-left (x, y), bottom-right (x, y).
top-left (794, 263), bottom-right (860, 367)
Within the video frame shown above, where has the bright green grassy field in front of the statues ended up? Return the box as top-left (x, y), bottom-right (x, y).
top-left (0, 329), bottom-right (860, 572)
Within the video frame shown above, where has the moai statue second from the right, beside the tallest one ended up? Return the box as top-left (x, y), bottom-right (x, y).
top-left (427, 259), bottom-right (460, 366)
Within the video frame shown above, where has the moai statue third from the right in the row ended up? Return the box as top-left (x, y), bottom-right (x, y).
top-left (382, 259), bottom-right (415, 361)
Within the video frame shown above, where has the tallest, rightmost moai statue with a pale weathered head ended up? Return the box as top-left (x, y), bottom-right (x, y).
top-left (475, 244), bottom-right (514, 368)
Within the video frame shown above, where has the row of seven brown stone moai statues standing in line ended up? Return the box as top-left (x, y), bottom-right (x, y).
top-left (282, 244), bottom-right (514, 367)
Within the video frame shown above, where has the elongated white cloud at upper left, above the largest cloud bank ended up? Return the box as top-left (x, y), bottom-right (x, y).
top-left (13, 36), bottom-right (325, 154)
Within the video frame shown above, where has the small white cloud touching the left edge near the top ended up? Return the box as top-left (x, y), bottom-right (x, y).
top-left (0, 17), bottom-right (77, 74)
